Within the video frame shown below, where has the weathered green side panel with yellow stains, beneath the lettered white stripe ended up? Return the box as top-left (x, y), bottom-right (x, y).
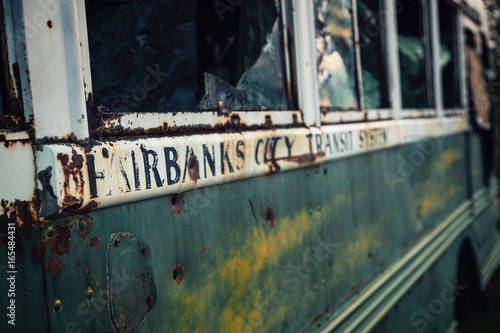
top-left (34, 130), bottom-right (484, 332)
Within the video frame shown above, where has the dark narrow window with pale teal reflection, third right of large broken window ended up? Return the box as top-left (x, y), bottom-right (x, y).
top-left (397, 0), bottom-right (432, 109)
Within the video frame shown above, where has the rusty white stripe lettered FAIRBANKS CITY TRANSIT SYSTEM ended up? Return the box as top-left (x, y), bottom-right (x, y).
top-left (37, 117), bottom-right (468, 218)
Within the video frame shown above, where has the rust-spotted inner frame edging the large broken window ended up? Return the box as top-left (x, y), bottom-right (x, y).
top-left (79, 0), bottom-right (304, 139)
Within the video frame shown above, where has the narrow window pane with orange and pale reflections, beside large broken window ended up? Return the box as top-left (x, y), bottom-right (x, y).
top-left (314, 0), bottom-right (359, 110)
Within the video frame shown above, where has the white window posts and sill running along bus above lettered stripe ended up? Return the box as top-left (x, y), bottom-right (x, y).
top-left (19, 0), bottom-right (478, 141)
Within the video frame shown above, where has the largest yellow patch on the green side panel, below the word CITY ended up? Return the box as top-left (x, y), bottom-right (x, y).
top-left (171, 206), bottom-right (320, 332)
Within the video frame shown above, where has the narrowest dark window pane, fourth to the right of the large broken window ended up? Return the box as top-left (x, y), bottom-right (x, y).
top-left (439, 1), bottom-right (461, 109)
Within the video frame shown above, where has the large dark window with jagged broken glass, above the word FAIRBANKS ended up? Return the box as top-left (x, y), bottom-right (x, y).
top-left (86, 0), bottom-right (291, 112)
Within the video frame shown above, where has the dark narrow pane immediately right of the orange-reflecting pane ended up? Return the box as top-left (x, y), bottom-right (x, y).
top-left (356, 0), bottom-right (389, 109)
